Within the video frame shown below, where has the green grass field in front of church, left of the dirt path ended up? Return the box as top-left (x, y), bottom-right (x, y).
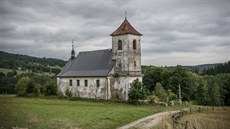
top-left (0, 95), bottom-right (185, 129)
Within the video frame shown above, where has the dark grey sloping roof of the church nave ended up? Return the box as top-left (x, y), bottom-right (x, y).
top-left (57, 49), bottom-right (115, 77)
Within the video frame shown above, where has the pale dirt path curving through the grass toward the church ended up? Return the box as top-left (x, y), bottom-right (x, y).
top-left (118, 110), bottom-right (179, 129)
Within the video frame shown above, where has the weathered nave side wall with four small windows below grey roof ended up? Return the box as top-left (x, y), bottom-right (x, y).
top-left (57, 77), bottom-right (108, 99)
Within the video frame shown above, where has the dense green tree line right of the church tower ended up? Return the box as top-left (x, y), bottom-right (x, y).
top-left (129, 66), bottom-right (230, 105)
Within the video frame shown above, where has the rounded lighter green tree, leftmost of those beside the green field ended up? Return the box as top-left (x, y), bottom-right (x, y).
top-left (16, 77), bottom-right (30, 96)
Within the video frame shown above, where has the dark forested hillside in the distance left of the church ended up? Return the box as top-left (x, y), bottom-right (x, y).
top-left (0, 51), bottom-right (66, 73)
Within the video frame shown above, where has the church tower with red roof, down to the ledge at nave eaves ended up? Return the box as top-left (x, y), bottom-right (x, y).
top-left (110, 18), bottom-right (142, 78)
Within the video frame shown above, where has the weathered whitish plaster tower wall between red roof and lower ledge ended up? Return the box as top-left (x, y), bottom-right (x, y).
top-left (112, 34), bottom-right (141, 76)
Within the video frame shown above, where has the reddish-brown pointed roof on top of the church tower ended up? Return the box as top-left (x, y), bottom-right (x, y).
top-left (110, 18), bottom-right (142, 36)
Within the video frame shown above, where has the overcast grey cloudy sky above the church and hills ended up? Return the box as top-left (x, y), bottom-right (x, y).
top-left (0, 0), bottom-right (230, 66)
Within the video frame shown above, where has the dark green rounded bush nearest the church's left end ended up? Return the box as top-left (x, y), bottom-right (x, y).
top-left (45, 81), bottom-right (58, 95)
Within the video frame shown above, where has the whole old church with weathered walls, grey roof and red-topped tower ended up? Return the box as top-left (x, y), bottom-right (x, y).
top-left (57, 18), bottom-right (142, 100)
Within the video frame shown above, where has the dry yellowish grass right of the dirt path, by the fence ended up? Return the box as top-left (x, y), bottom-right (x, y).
top-left (153, 107), bottom-right (230, 129)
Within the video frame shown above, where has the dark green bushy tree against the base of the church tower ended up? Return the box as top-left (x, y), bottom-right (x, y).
top-left (128, 79), bottom-right (147, 101)
